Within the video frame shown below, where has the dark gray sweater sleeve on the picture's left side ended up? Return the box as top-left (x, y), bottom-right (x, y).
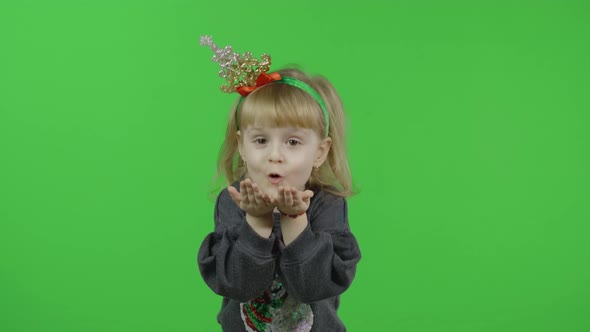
top-left (197, 189), bottom-right (276, 302)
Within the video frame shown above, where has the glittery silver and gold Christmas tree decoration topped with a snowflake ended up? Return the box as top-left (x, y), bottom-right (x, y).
top-left (201, 36), bottom-right (270, 93)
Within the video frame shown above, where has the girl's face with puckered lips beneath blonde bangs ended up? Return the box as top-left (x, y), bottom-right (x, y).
top-left (238, 125), bottom-right (331, 196)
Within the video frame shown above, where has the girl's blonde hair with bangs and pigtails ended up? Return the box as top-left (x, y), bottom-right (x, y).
top-left (217, 68), bottom-right (353, 197)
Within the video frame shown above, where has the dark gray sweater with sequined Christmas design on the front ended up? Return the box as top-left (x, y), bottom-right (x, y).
top-left (198, 184), bottom-right (361, 332)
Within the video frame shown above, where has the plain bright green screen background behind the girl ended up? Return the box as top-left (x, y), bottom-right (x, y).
top-left (0, 0), bottom-right (590, 332)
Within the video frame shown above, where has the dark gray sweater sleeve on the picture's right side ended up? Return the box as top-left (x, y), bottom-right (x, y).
top-left (279, 192), bottom-right (361, 303)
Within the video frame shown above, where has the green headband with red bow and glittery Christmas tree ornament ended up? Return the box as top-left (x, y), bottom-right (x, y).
top-left (201, 36), bottom-right (330, 137)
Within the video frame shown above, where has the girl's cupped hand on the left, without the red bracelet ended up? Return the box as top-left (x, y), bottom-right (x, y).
top-left (228, 179), bottom-right (275, 217)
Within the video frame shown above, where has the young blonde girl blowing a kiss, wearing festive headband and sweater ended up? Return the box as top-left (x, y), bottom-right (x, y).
top-left (198, 37), bottom-right (361, 332)
